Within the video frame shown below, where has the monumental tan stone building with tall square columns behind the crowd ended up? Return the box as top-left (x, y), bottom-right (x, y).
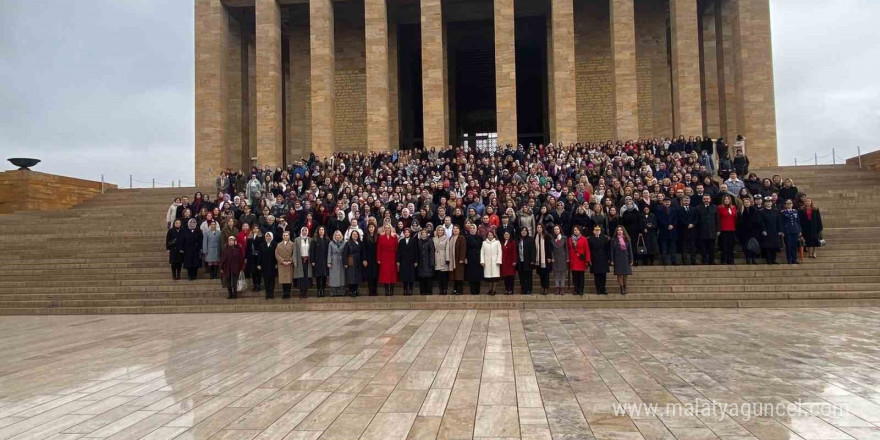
top-left (194, 0), bottom-right (777, 184)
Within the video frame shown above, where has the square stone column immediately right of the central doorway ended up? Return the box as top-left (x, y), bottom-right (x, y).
top-left (494, 0), bottom-right (517, 147)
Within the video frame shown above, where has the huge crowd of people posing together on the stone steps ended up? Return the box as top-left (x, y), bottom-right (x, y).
top-left (166, 137), bottom-right (824, 298)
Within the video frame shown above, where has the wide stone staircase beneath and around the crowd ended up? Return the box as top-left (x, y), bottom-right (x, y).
top-left (0, 165), bottom-right (880, 315)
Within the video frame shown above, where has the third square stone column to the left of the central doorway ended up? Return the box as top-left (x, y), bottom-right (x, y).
top-left (309, 0), bottom-right (336, 160)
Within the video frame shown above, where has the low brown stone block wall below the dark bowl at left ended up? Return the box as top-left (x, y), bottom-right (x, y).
top-left (0, 170), bottom-right (116, 214)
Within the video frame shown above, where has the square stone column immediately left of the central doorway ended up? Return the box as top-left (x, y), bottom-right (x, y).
top-left (420, 0), bottom-right (449, 148)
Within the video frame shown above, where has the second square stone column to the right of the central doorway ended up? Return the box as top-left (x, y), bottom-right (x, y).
top-left (548, 0), bottom-right (577, 144)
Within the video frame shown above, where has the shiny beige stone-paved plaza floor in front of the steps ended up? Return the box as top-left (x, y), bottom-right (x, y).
top-left (0, 308), bottom-right (880, 440)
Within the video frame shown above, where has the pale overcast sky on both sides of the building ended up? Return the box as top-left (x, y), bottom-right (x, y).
top-left (0, 0), bottom-right (880, 186)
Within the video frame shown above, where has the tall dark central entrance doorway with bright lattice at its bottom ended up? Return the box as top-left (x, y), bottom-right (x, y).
top-left (446, 20), bottom-right (497, 147)
